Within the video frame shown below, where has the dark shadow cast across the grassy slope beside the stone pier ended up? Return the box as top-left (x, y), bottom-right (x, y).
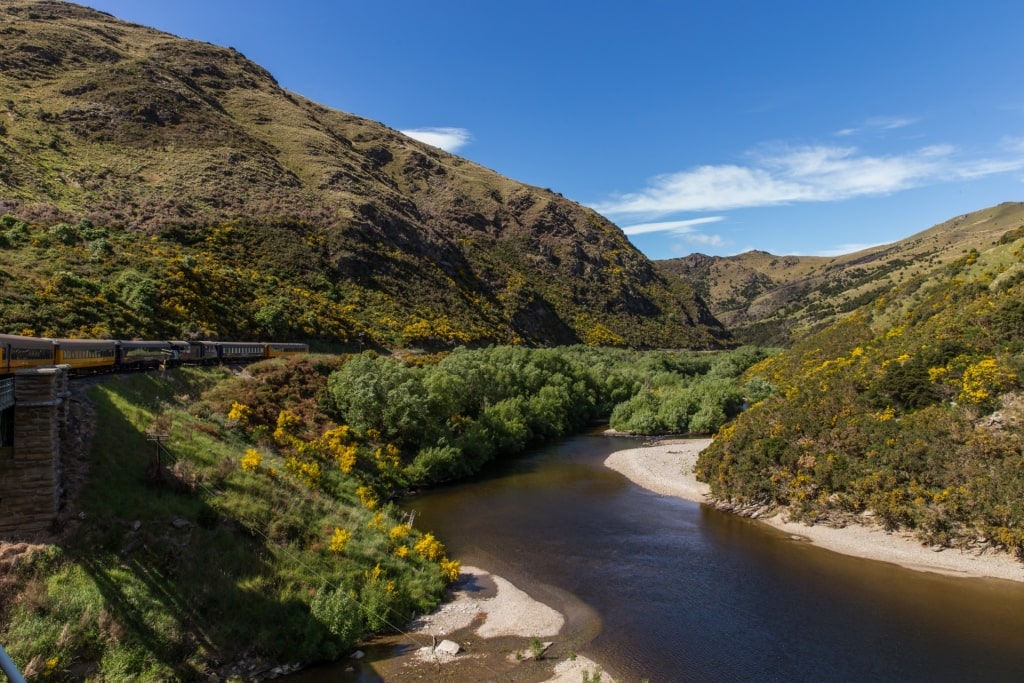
top-left (68, 378), bottom-right (339, 680)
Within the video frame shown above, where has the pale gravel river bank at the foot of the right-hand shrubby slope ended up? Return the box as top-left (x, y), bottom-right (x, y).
top-left (604, 439), bottom-right (1024, 582)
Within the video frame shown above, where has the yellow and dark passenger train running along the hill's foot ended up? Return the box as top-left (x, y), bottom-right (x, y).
top-left (0, 334), bottom-right (309, 375)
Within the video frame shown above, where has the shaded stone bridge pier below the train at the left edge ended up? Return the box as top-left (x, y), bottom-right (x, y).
top-left (0, 366), bottom-right (70, 539)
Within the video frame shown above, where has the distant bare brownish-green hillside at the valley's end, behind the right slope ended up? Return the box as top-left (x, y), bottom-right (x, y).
top-left (657, 203), bottom-right (1024, 346)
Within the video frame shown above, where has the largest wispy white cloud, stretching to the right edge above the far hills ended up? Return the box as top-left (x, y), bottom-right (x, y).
top-left (594, 140), bottom-right (1024, 218)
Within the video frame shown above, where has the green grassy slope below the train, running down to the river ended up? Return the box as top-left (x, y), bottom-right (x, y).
top-left (0, 362), bottom-right (444, 681)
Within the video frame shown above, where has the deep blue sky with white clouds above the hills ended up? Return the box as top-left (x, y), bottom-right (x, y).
top-left (83, 0), bottom-right (1024, 259)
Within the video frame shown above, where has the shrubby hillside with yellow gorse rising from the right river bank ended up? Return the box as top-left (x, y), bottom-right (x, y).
top-left (697, 223), bottom-right (1024, 555)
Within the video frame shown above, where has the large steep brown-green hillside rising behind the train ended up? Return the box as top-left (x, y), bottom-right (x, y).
top-left (0, 0), bottom-right (726, 347)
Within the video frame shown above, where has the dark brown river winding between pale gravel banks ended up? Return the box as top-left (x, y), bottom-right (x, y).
top-left (296, 435), bottom-right (1024, 683)
